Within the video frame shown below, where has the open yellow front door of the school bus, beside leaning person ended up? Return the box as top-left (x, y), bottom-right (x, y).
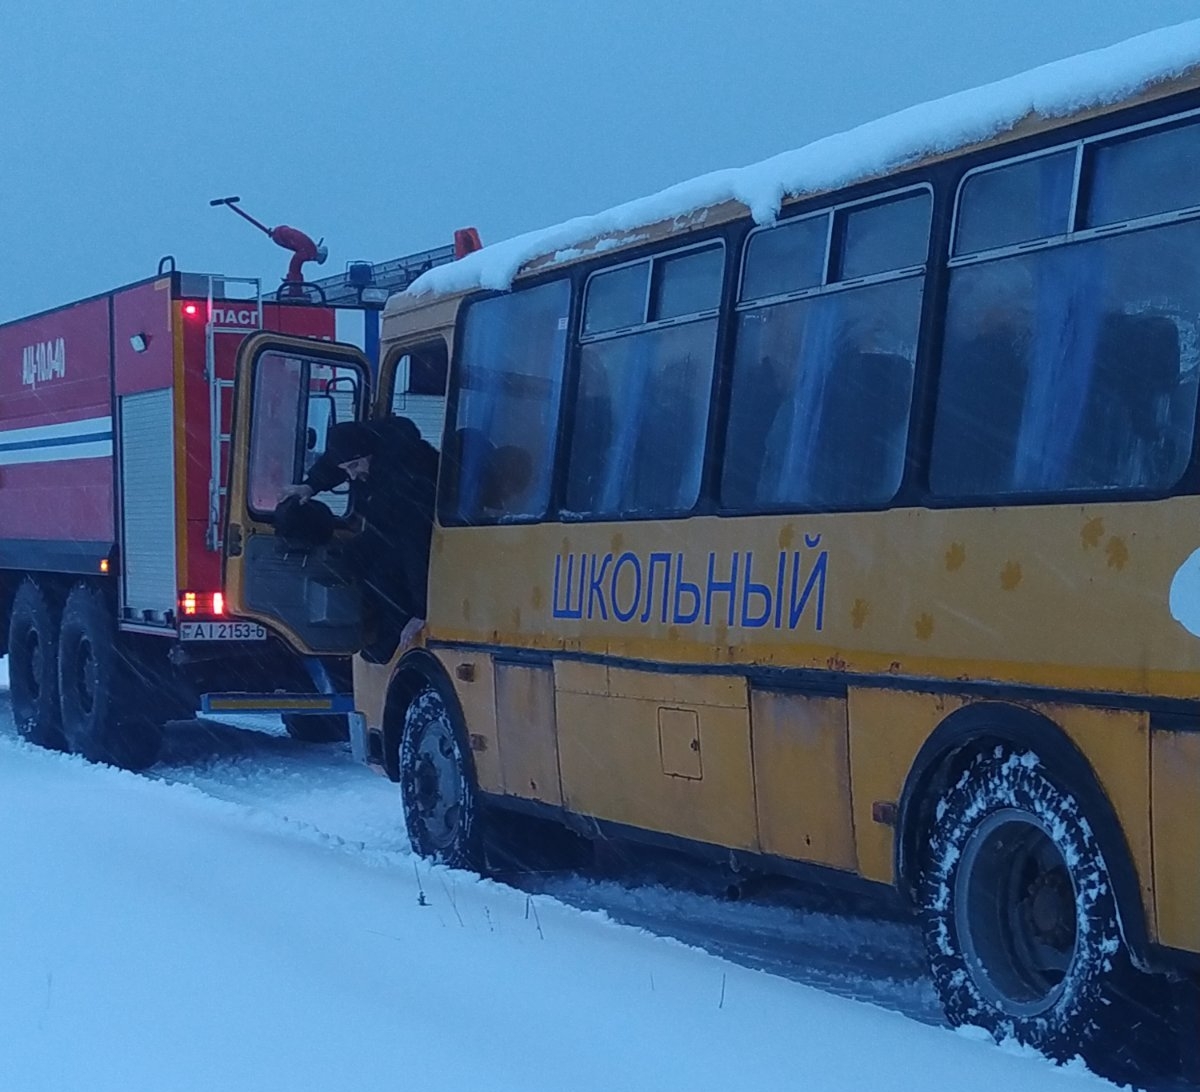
top-left (224, 334), bottom-right (371, 655)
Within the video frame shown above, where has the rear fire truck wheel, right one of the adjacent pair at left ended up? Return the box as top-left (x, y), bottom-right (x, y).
top-left (59, 584), bottom-right (162, 769)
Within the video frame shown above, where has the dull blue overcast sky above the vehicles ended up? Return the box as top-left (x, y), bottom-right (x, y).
top-left (0, 0), bottom-right (1200, 322)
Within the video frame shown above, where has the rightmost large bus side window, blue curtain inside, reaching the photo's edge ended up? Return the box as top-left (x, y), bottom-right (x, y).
top-left (930, 124), bottom-right (1200, 499)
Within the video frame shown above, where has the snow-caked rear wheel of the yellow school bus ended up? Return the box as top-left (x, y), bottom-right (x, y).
top-left (918, 746), bottom-right (1128, 1058)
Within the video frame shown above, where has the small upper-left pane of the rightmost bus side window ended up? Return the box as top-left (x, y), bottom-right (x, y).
top-left (954, 148), bottom-right (1076, 257)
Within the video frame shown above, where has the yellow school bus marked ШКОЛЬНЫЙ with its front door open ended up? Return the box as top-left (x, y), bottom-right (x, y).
top-left (226, 38), bottom-right (1200, 1054)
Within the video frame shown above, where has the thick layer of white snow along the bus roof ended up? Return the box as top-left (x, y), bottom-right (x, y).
top-left (408, 19), bottom-right (1200, 295)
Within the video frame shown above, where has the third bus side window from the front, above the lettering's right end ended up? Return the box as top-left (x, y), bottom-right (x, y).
top-left (721, 191), bottom-right (932, 510)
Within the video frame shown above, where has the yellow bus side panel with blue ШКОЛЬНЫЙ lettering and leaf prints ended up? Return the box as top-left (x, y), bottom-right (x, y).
top-left (430, 497), bottom-right (1200, 700)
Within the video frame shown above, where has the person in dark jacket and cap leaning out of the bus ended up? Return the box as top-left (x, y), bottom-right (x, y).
top-left (284, 418), bottom-right (438, 659)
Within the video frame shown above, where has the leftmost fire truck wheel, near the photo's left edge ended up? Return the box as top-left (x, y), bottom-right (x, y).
top-left (8, 580), bottom-right (67, 750)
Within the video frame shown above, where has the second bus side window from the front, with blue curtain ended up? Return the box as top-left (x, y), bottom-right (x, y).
top-left (566, 245), bottom-right (725, 516)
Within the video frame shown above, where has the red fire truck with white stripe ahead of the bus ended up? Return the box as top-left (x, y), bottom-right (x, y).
top-left (0, 241), bottom-right (454, 768)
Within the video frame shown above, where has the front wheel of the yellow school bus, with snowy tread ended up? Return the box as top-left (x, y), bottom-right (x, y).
top-left (400, 685), bottom-right (484, 871)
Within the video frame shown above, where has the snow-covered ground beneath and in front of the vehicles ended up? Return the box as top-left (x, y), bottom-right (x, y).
top-left (0, 681), bottom-right (1128, 1092)
